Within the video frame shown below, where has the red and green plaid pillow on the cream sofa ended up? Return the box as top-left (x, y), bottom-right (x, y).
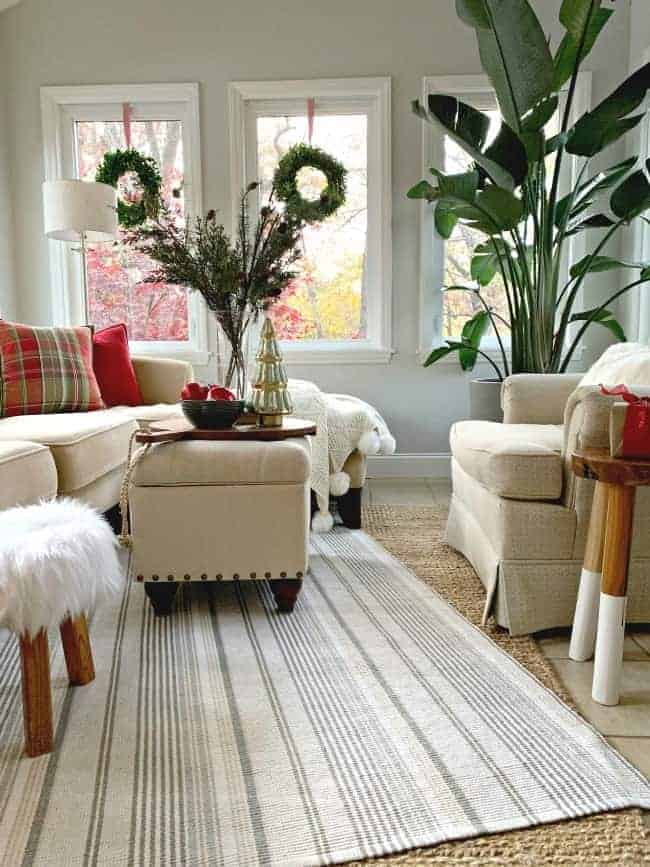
top-left (0, 321), bottom-right (104, 418)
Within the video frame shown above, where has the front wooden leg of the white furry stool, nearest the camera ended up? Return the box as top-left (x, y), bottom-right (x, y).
top-left (19, 629), bottom-right (54, 758)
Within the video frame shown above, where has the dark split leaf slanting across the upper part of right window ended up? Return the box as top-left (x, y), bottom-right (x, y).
top-left (413, 94), bottom-right (528, 188)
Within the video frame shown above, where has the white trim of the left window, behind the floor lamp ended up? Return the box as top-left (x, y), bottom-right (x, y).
top-left (41, 83), bottom-right (209, 364)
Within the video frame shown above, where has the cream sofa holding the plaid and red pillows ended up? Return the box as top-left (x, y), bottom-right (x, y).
top-left (0, 357), bottom-right (192, 512)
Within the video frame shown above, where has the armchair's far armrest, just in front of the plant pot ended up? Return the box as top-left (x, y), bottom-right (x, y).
top-left (501, 373), bottom-right (582, 424)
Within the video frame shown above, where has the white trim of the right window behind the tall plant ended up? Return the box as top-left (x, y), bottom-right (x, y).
top-left (419, 72), bottom-right (592, 364)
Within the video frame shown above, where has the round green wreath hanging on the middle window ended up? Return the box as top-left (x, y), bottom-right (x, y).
top-left (273, 144), bottom-right (347, 223)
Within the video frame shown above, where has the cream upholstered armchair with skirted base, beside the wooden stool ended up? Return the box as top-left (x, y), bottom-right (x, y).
top-left (447, 347), bottom-right (650, 635)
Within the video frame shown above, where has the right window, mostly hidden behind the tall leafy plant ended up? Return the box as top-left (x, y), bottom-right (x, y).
top-left (420, 73), bottom-right (591, 360)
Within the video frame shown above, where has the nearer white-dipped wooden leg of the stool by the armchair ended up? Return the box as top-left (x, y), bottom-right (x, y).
top-left (591, 485), bottom-right (635, 705)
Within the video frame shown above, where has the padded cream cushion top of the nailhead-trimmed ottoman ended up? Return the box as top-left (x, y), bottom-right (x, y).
top-left (131, 438), bottom-right (311, 487)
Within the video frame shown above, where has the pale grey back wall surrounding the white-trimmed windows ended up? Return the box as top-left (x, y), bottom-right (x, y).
top-left (0, 0), bottom-right (629, 453)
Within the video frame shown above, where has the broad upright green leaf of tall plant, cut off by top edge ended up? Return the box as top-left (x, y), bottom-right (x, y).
top-left (465, 0), bottom-right (554, 130)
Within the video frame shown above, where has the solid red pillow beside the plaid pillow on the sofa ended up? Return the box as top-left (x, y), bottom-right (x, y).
top-left (93, 323), bottom-right (144, 406)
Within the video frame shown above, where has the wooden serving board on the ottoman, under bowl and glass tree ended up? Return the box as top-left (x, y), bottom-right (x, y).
top-left (135, 416), bottom-right (316, 445)
